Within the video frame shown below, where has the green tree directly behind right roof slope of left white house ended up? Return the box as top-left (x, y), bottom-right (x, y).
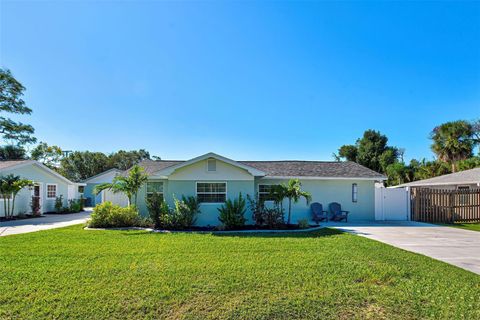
top-left (59, 151), bottom-right (111, 182)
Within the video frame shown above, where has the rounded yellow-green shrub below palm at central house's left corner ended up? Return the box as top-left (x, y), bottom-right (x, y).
top-left (88, 202), bottom-right (142, 228)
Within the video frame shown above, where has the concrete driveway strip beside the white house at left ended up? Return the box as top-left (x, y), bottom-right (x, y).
top-left (0, 210), bottom-right (91, 236)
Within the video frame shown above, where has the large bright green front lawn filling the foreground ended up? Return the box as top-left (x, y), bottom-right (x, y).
top-left (0, 226), bottom-right (480, 319)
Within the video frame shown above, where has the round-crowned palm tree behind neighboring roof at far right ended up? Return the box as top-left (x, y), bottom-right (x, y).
top-left (430, 120), bottom-right (476, 172)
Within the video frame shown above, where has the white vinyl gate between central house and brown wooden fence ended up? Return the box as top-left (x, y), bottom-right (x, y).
top-left (375, 187), bottom-right (410, 221)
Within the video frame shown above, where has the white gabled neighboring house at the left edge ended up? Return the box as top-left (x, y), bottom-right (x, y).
top-left (0, 160), bottom-right (84, 217)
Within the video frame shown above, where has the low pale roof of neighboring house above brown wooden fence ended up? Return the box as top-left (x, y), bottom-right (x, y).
top-left (394, 168), bottom-right (480, 190)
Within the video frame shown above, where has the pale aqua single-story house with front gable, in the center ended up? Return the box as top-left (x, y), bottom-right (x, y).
top-left (123, 153), bottom-right (386, 226)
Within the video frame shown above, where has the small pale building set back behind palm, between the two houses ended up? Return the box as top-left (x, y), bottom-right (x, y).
top-left (82, 168), bottom-right (127, 206)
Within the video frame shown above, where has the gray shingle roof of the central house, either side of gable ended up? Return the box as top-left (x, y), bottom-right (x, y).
top-left (140, 160), bottom-right (385, 180)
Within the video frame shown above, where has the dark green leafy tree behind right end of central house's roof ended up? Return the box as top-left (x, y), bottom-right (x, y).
top-left (335, 130), bottom-right (400, 173)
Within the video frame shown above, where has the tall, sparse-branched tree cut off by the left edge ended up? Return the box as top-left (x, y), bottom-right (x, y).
top-left (0, 68), bottom-right (36, 146)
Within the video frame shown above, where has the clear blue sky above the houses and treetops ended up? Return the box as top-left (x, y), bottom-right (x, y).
top-left (0, 1), bottom-right (480, 160)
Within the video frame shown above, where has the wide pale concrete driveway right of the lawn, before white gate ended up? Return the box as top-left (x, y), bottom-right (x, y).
top-left (324, 221), bottom-right (480, 274)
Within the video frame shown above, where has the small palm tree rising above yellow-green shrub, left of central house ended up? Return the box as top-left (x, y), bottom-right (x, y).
top-left (93, 165), bottom-right (148, 205)
